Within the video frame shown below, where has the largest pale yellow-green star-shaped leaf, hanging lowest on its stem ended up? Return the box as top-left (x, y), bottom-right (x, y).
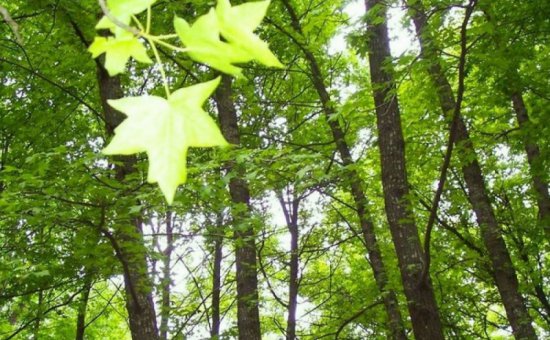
top-left (102, 77), bottom-right (229, 204)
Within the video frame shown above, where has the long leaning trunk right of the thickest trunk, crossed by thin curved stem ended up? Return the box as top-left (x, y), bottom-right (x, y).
top-left (409, 2), bottom-right (536, 339)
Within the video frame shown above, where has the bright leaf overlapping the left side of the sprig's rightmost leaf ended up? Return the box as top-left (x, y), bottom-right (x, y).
top-left (174, 9), bottom-right (253, 77)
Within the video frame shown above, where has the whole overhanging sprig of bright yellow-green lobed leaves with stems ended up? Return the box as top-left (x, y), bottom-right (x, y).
top-left (89, 0), bottom-right (283, 204)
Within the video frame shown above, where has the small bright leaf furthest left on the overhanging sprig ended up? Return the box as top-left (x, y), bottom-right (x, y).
top-left (88, 32), bottom-right (152, 76)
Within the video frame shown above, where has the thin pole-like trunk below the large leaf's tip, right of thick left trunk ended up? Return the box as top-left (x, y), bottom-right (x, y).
top-left (160, 210), bottom-right (174, 340)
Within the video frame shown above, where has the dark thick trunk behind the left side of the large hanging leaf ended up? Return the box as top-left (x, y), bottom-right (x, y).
top-left (97, 62), bottom-right (159, 340)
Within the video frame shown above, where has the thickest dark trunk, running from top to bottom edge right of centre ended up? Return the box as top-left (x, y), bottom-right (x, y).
top-left (365, 0), bottom-right (443, 339)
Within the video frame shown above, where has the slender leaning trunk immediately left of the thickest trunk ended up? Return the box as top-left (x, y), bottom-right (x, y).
top-left (282, 0), bottom-right (406, 339)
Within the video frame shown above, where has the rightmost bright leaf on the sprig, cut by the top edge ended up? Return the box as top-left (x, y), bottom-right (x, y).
top-left (216, 0), bottom-right (283, 67)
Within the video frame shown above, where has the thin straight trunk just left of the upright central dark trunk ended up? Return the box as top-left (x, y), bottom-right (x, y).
top-left (210, 213), bottom-right (223, 339)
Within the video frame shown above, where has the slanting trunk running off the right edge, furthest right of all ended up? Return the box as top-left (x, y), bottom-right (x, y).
top-left (511, 92), bottom-right (550, 241)
